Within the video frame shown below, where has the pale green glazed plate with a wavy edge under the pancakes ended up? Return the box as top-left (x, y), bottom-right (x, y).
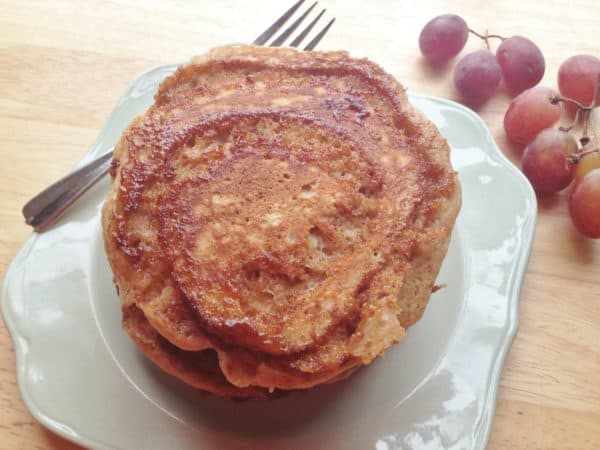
top-left (2, 65), bottom-right (536, 450)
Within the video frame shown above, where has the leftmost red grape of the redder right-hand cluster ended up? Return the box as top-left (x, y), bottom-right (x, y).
top-left (504, 86), bottom-right (561, 145)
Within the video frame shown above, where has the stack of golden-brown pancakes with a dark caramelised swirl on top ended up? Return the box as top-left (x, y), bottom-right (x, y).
top-left (103, 46), bottom-right (460, 397)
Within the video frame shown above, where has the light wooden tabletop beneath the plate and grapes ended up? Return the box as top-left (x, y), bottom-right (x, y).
top-left (0, 0), bottom-right (600, 450)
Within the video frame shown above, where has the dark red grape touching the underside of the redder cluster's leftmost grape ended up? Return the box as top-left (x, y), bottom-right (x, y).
top-left (521, 128), bottom-right (577, 194)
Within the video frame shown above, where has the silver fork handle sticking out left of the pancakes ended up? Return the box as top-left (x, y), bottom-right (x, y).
top-left (23, 151), bottom-right (112, 231)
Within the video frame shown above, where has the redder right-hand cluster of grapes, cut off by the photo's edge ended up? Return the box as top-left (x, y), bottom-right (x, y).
top-left (504, 55), bottom-right (600, 238)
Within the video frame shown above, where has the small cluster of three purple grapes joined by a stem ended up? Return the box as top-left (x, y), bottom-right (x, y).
top-left (419, 14), bottom-right (546, 106)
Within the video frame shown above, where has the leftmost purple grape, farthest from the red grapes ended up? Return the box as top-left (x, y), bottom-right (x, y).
top-left (419, 14), bottom-right (469, 64)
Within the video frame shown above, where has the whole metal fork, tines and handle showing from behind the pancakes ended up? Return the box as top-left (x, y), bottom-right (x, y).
top-left (23, 0), bottom-right (335, 232)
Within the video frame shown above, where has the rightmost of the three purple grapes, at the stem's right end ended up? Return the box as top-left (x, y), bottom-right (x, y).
top-left (496, 36), bottom-right (546, 93)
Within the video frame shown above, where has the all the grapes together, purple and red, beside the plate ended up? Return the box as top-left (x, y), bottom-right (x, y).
top-left (419, 14), bottom-right (600, 238)
